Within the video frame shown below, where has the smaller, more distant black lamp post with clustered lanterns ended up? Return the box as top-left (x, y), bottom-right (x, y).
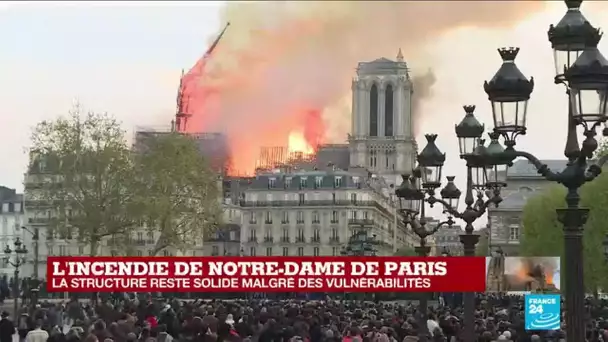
top-left (399, 116), bottom-right (506, 342)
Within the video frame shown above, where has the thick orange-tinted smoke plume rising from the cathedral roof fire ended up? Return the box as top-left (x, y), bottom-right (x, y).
top-left (188, 1), bottom-right (544, 172)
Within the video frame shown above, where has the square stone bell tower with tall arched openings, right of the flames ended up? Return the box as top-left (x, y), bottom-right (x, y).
top-left (349, 49), bottom-right (416, 184)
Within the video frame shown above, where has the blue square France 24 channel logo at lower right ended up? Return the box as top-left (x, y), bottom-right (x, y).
top-left (524, 294), bottom-right (561, 330)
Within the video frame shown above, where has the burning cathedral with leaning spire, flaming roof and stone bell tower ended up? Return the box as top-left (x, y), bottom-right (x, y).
top-left (146, 23), bottom-right (417, 184)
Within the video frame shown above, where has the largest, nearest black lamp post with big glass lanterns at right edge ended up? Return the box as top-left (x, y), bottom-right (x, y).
top-left (484, 0), bottom-right (608, 341)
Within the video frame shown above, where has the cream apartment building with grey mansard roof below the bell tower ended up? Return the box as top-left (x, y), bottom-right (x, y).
top-left (235, 168), bottom-right (415, 256)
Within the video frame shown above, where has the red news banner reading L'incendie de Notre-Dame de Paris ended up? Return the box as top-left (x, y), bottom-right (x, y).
top-left (47, 257), bottom-right (486, 292)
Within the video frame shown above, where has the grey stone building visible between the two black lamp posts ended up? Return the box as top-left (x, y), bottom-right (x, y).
top-left (488, 159), bottom-right (567, 256)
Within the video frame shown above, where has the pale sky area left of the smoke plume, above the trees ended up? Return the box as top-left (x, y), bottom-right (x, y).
top-left (0, 2), bottom-right (220, 189)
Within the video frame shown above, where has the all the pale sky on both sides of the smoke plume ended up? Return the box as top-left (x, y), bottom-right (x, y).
top-left (0, 1), bottom-right (608, 230)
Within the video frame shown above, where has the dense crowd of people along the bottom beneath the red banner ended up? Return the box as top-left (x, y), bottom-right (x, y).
top-left (0, 294), bottom-right (608, 342)
